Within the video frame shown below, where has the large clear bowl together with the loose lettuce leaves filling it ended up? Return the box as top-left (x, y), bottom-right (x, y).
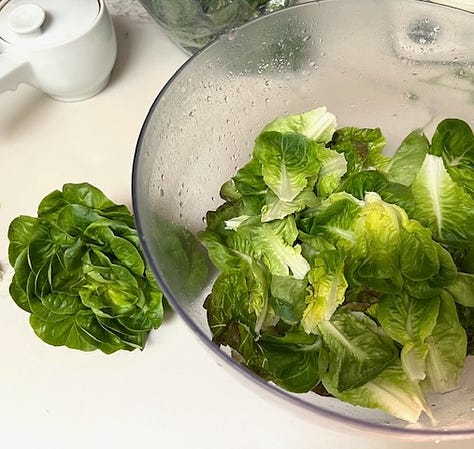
top-left (133, 0), bottom-right (474, 438)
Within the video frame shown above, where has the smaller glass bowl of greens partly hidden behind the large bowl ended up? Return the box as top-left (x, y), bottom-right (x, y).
top-left (135, 0), bottom-right (294, 54)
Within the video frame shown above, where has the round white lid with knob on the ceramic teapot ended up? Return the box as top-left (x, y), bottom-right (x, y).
top-left (0, 0), bottom-right (103, 48)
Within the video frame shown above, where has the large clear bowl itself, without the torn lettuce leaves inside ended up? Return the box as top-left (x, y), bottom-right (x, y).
top-left (132, 0), bottom-right (474, 439)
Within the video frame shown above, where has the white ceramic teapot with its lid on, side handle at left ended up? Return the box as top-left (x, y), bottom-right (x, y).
top-left (0, 0), bottom-right (117, 101)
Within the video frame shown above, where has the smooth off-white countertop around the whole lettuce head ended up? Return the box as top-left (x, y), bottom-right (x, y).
top-left (0, 12), bottom-right (472, 449)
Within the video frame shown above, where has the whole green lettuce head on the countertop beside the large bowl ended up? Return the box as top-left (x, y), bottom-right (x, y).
top-left (8, 183), bottom-right (163, 353)
